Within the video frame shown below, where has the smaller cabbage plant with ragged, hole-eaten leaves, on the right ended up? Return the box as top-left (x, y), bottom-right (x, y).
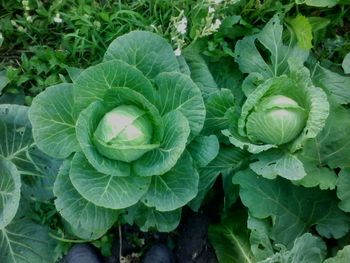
top-left (222, 15), bottom-right (329, 181)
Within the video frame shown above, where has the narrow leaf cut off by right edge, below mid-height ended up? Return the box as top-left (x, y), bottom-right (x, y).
top-left (337, 168), bottom-right (350, 212)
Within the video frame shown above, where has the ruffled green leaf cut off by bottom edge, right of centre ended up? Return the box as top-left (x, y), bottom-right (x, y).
top-left (259, 233), bottom-right (327, 263)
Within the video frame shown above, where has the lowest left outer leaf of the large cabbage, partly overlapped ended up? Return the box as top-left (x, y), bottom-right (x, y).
top-left (54, 160), bottom-right (118, 239)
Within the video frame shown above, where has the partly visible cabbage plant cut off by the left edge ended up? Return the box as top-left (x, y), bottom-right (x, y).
top-left (0, 104), bottom-right (61, 263)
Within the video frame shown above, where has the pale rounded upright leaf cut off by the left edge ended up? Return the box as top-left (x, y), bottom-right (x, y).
top-left (0, 159), bottom-right (21, 229)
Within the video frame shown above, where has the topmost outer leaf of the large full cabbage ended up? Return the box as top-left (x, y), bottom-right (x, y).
top-left (104, 31), bottom-right (180, 79)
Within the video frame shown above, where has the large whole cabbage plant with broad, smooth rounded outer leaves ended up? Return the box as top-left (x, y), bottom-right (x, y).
top-left (29, 31), bottom-right (218, 238)
